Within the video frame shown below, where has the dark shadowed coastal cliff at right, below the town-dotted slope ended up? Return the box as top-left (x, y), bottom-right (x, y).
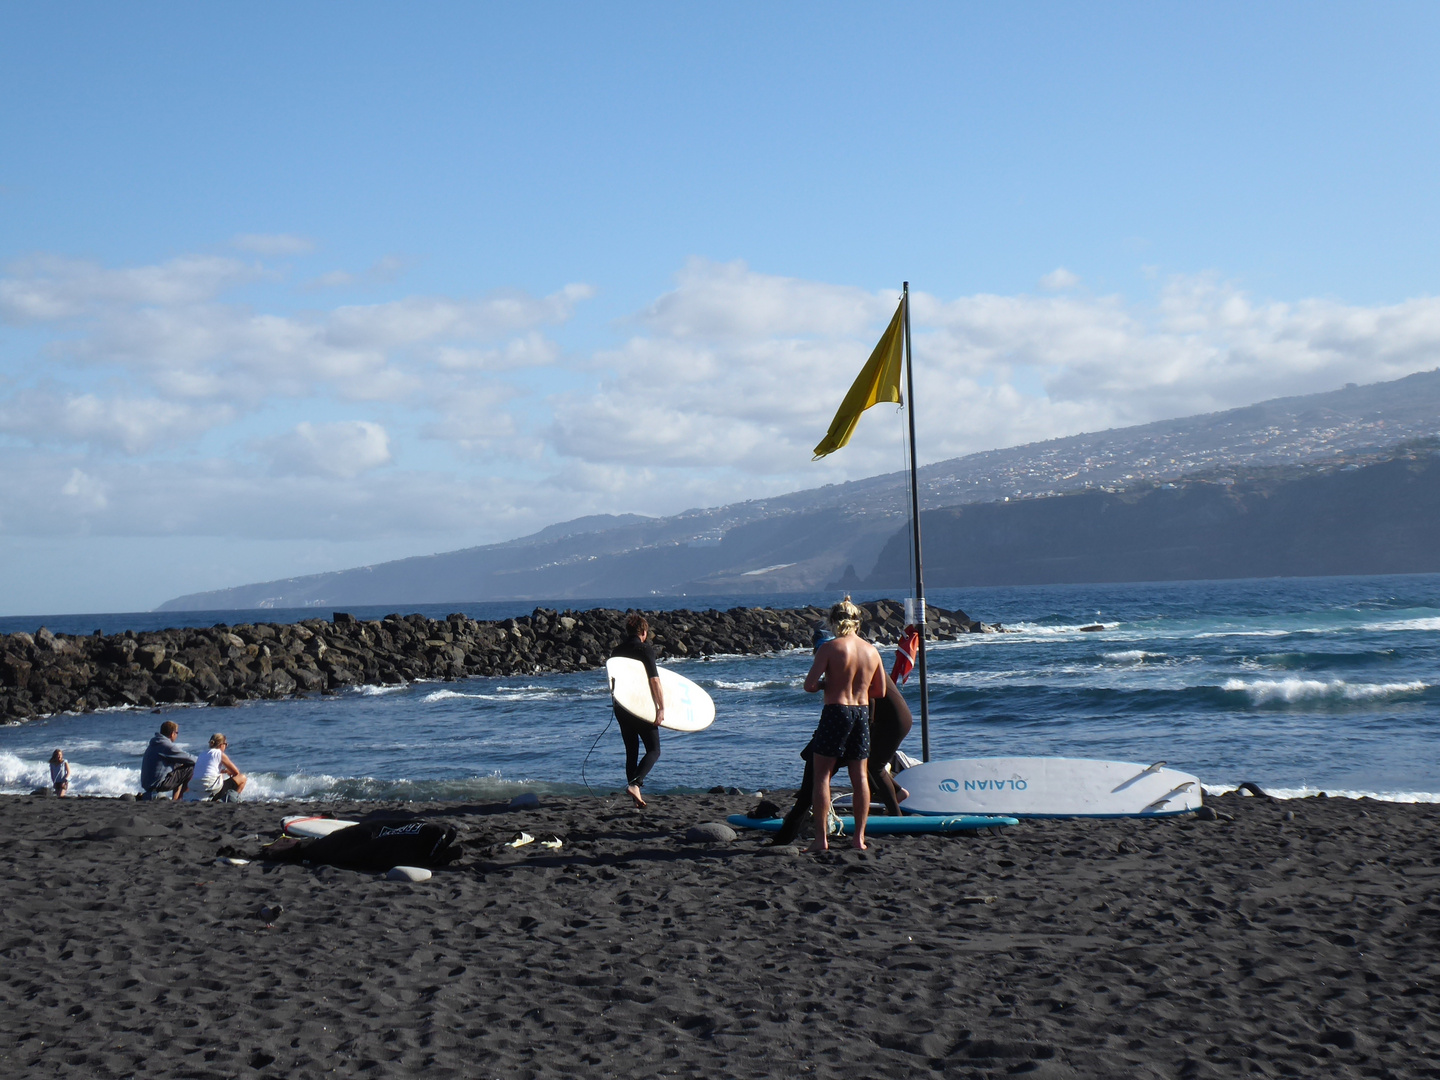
top-left (852, 445), bottom-right (1440, 590)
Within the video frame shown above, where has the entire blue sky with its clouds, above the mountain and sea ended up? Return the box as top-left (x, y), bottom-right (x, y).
top-left (0, 3), bottom-right (1440, 613)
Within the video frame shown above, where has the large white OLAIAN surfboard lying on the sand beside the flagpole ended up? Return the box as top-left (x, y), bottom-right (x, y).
top-left (894, 757), bottom-right (1202, 818)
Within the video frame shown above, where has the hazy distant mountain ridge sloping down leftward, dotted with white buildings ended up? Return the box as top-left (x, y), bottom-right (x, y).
top-left (158, 370), bottom-right (1440, 611)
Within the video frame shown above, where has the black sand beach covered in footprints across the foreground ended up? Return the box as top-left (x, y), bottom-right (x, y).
top-left (0, 795), bottom-right (1440, 1080)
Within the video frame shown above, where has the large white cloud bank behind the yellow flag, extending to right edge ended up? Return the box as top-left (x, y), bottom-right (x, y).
top-left (550, 261), bottom-right (1440, 487)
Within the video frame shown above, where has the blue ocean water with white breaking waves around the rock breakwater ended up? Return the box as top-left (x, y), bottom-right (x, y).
top-left (0, 575), bottom-right (1440, 802)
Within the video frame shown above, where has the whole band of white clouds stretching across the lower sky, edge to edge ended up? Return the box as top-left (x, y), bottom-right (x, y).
top-left (8, 247), bottom-right (1440, 567)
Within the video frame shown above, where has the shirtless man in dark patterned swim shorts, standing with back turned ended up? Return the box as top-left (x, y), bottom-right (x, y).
top-left (805, 596), bottom-right (886, 851)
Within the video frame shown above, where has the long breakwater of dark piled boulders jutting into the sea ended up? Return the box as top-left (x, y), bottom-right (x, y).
top-left (0, 600), bottom-right (994, 721)
